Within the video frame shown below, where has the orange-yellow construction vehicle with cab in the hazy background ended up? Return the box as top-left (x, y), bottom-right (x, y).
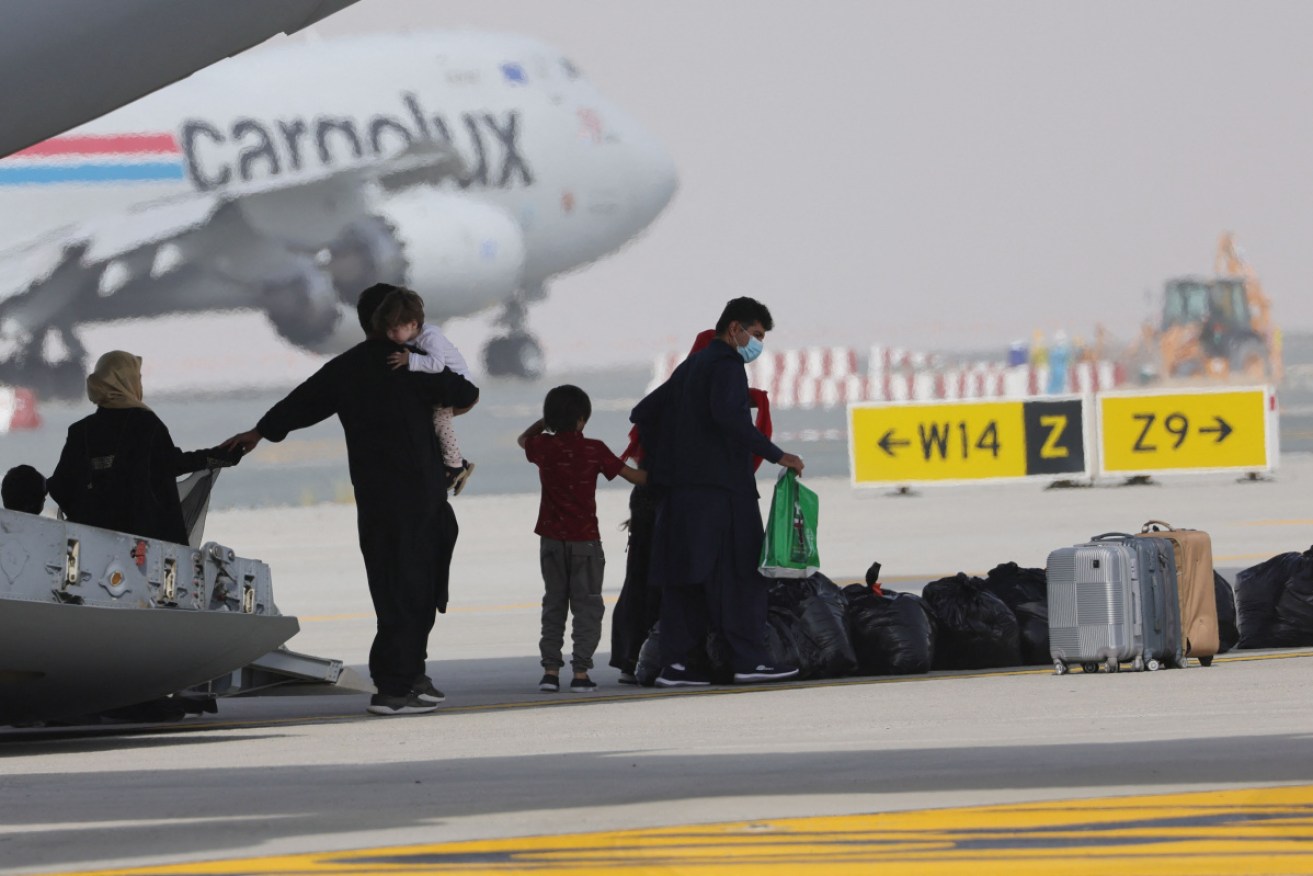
top-left (1146, 232), bottom-right (1281, 383)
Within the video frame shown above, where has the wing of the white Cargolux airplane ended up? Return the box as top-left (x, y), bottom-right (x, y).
top-left (0, 141), bottom-right (465, 307)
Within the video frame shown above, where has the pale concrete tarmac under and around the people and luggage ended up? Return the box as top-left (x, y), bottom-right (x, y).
top-left (0, 454), bottom-right (1313, 873)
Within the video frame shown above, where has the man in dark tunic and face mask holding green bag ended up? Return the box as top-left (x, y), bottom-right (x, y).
top-left (629, 298), bottom-right (802, 687)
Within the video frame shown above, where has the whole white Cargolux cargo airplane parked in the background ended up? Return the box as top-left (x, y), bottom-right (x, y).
top-left (0, 33), bottom-right (676, 394)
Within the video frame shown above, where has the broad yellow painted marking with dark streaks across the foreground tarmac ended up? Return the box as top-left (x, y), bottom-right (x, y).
top-left (41, 785), bottom-right (1313, 876)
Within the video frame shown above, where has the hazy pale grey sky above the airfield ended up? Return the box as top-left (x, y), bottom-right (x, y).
top-left (309, 0), bottom-right (1313, 366)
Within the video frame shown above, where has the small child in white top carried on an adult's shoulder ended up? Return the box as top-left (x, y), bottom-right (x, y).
top-left (374, 288), bottom-right (474, 495)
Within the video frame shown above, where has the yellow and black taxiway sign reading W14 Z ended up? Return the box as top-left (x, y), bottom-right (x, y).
top-left (848, 395), bottom-right (1090, 486)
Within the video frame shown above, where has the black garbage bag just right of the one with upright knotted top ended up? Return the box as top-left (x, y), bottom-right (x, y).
top-left (922, 573), bottom-right (1022, 670)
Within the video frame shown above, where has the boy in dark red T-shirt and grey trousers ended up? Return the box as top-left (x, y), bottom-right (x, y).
top-left (519, 385), bottom-right (647, 693)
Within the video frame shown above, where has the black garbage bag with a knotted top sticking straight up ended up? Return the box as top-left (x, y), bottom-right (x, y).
top-left (846, 593), bottom-right (935, 675)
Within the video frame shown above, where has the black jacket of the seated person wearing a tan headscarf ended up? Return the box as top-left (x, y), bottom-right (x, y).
top-left (47, 407), bottom-right (235, 545)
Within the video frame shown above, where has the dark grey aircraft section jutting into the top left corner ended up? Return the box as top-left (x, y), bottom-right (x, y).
top-left (0, 0), bottom-right (356, 156)
